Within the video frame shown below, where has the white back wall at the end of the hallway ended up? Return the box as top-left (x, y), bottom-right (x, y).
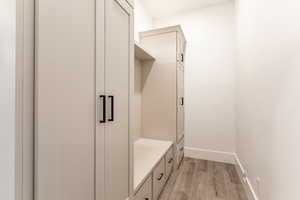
top-left (154, 2), bottom-right (236, 159)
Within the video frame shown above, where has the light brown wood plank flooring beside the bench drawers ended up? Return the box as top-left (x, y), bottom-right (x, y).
top-left (159, 158), bottom-right (247, 200)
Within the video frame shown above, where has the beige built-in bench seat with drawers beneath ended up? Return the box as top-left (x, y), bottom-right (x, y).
top-left (133, 138), bottom-right (173, 200)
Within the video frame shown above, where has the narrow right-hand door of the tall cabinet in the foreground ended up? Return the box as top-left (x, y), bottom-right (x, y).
top-left (105, 0), bottom-right (133, 200)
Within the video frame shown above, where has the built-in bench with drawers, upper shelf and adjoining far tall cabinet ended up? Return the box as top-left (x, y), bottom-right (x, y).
top-left (133, 25), bottom-right (186, 200)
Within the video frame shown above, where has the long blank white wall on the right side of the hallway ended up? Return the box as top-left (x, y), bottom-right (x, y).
top-left (237, 0), bottom-right (300, 200)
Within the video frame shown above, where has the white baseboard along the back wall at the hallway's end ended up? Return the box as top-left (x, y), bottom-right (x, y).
top-left (184, 147), bottom-right (235, 164)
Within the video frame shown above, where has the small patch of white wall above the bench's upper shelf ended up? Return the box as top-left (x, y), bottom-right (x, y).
top-left (134, 0), bottom-right (152, 41)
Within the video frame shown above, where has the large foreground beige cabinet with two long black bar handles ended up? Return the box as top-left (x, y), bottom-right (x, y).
top-left (35, 0), bottom-right (134, 200)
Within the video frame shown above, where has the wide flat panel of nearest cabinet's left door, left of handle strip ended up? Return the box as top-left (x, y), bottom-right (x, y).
top-left (35, 0), bottom-right (95, 200)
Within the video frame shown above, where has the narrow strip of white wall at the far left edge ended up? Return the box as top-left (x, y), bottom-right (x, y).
top-left (0, 0), bottom-right (16, 200)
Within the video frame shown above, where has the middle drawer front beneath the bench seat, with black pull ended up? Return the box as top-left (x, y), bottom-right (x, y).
top-left (153, 158), bottom-right (166, 200)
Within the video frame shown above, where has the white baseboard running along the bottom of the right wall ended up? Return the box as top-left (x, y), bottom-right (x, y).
top-left (235, 154), bottom-right (259, 200)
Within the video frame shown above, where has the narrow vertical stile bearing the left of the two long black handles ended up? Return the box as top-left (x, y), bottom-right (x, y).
top-left (95, 0), bottom-right (106, 200)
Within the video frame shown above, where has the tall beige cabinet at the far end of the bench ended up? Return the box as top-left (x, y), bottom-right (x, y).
top-left (140, 26), bottom-right (186, 165)
